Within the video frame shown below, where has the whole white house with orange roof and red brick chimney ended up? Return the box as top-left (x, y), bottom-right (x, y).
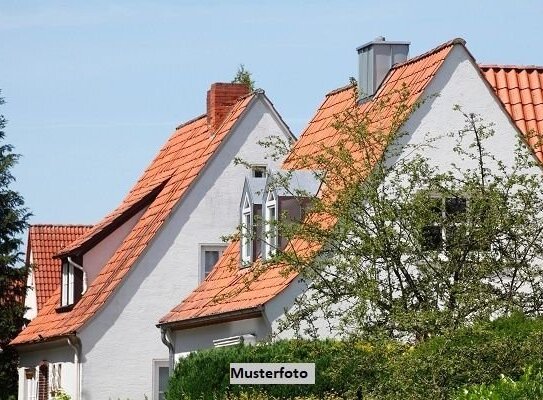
top-left (12, 83), bottom-right (292, 400)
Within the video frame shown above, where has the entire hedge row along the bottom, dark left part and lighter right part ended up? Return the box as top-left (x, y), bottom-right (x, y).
top-left (166, 315), bottom-right (543, 400)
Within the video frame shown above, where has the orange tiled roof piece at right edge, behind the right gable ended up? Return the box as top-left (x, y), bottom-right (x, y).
top-left (480, 65), bottom-right (543, 162)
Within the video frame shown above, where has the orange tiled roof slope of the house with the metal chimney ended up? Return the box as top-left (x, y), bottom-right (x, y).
top-left (159, 39), bottom-right (465, 328)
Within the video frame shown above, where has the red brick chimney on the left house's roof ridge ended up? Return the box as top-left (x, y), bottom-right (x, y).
top-left (207, 83), bottom-right (249, 132)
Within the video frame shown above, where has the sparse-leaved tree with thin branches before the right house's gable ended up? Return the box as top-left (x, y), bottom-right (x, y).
top-left (257, 84), bottom-right (543, 341)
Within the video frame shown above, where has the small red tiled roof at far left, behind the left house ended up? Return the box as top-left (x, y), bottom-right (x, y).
top-left (26, 225), bottom-right (91, 312)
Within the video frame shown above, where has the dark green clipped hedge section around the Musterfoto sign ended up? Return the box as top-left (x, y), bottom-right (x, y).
top-left (166, 340), bottom-right (401, 400)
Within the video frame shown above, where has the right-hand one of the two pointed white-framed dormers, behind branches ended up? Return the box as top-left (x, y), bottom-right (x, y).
top-left (261, 171), bottom-right (320, 259)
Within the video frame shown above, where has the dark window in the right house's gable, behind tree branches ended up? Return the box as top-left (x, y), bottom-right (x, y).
top-left (422, 197), bottom-right (467, 250)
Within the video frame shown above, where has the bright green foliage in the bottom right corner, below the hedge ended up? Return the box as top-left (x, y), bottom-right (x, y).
top-left (454, 368), bottom-right (543, 400)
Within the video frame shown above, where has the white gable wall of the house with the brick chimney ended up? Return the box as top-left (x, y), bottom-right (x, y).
top-left (76, 98), bottom-right (294, 400)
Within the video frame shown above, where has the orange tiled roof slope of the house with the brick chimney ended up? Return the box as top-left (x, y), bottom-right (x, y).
top-left (12, 93), bottom-right (259, 345)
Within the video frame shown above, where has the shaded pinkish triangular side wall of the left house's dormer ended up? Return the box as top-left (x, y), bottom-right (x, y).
top-left (83, 209), bottom-right (145, 286)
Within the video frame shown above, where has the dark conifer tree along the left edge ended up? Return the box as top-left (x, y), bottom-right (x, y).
top-left (0, 91), bottom-right (29, 399)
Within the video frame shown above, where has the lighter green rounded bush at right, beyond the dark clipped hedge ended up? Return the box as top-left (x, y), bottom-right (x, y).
top-left (376, 315), bottom-right (543, 400)
